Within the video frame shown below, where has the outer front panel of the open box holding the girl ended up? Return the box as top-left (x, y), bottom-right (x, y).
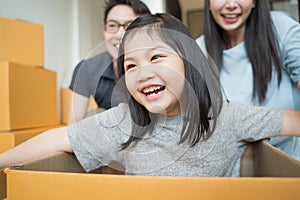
top-left (5, 169), bottom-right (300, 200)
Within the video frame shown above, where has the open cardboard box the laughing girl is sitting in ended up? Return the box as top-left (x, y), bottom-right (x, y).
top-left (0, 141), bottom-right (300, 200)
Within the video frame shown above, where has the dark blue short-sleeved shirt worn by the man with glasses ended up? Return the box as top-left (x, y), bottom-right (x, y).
top-left (69, 52), bottom-right (119, 109)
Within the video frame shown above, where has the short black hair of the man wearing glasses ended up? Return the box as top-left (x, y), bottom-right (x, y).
top-left (104, 0), bottom-right (151, 24)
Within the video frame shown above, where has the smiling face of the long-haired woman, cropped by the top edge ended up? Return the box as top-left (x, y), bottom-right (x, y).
top-left (209, 0), bottom-right (255, 34)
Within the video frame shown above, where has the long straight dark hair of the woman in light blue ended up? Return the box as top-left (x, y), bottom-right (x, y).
top-left (203, 0), bottom-right (282, 103)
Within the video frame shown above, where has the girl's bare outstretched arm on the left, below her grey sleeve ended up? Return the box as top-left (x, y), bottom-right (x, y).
top-left (0, 127), bottom-right (73, 169)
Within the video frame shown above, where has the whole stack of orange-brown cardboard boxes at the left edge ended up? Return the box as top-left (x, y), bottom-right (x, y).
top-left (0, 17), bottom-right (59, 152)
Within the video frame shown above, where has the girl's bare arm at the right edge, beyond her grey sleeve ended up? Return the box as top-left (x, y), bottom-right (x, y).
top-left (279, 110), bottom-right (300, 137)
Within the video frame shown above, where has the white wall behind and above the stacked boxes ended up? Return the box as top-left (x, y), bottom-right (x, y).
top-left (0, 0), bottom-right (76, 86)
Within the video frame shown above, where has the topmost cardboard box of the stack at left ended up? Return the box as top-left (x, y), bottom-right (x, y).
top-left (0, 17), bottom-right (44, 66)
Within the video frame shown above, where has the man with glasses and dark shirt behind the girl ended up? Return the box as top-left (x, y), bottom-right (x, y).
top-left (69, 0), bottom-right (150, 123)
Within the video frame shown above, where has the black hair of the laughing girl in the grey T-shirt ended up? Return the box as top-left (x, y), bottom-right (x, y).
top-left (118, 14), bottom-right (222, 149)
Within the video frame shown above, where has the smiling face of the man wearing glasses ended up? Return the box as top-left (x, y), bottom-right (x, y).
top-left (103, 5), bottom-right (138, 60)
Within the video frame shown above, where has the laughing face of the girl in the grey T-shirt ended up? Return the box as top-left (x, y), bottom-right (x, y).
top-left (124, 31), bottom-right (185, 116)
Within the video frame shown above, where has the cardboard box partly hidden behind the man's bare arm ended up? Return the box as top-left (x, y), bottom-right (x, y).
top-left (60, 88), bottom-right (98, 124)
